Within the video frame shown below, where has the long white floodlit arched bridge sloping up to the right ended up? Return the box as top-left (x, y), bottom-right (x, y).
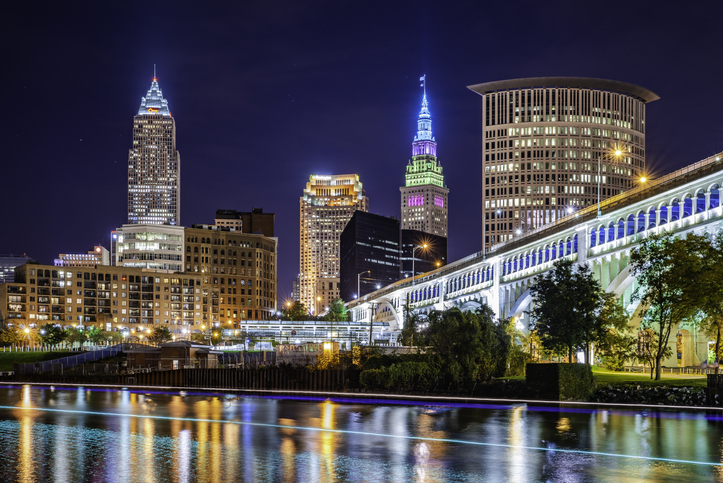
top-left (349, 153), bottom-right (723, 365)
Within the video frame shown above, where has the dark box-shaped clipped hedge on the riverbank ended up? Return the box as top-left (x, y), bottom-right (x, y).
top-left (527, 364), bottom-right (595, 401)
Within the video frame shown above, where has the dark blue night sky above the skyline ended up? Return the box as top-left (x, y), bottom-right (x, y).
top-left (5, 0), bottom-right (723, 298)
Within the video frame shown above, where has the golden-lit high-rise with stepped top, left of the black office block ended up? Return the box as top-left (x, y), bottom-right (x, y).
top-left (299, 174), bottom-right (369, 314)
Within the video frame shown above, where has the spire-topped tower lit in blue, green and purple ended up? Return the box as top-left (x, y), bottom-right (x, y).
top-left (399, 77), bottom-right (449, 237)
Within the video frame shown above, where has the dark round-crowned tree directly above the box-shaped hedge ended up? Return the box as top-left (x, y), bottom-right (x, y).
top-left (530, 258), bottom-right (605, 363)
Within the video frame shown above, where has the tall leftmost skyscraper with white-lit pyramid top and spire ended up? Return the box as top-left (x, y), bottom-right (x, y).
top-left (128, 74), bottom-right (181, 225)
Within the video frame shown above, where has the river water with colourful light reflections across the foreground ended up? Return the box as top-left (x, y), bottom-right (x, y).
top-left (0, 386), bottom-right (723, 482)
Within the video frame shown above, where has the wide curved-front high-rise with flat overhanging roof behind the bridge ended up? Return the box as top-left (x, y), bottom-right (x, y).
top-left (469, 77), bottom-right (659, 247)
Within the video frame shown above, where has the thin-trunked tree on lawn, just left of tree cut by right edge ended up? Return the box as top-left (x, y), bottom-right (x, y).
top-left (630, 233), bottom-right (698, 380)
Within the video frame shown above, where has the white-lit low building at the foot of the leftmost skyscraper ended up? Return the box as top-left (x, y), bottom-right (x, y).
top-left (116, 224), bottom-right (184, 272)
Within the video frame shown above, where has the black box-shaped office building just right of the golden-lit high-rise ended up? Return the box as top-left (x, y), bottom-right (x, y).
top-left (339, 211), bottom-right (399, 302)
